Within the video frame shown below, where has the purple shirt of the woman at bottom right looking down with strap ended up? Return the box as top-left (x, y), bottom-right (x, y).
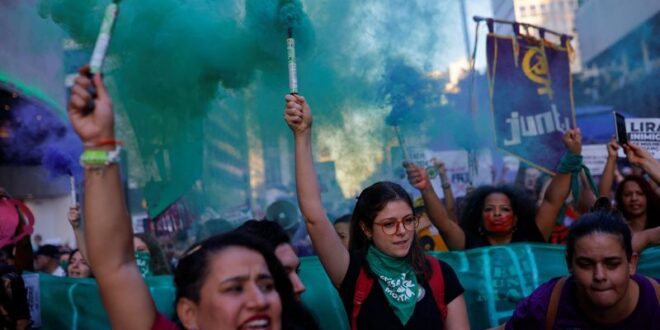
top-left (506, 274), bottom-right (660, 330)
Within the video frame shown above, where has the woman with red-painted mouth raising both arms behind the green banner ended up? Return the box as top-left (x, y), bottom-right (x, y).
top-left (406, 129), bottom-right (582, 250)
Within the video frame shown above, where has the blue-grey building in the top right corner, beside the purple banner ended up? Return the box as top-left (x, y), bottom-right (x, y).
top-left (575, 0), bottom-right (660, 117)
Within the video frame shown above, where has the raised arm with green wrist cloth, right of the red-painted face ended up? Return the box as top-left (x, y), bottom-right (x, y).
top-left (536, 128), bottom-right (582, 241)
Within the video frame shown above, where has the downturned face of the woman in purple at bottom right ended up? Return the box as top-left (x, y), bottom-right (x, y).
top-left (569, 232), bottom-right (637, 309)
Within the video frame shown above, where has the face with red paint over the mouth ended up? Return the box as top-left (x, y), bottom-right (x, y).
top-left (481, 193), bottom-right (517, 235)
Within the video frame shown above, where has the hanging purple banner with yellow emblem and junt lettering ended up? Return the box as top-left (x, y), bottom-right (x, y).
top-left (487, 34), bottom-right (575, 173)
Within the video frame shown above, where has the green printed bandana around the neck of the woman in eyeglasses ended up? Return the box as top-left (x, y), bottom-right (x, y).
top-left (367, 245), bottom-right (419, 325)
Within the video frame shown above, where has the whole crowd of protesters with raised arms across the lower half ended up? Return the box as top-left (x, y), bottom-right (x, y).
top-left (0, 74), bottom-right (660, 329)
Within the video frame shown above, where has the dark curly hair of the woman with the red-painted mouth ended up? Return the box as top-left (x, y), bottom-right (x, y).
top-left (459, 185), bottom-right (536, 240)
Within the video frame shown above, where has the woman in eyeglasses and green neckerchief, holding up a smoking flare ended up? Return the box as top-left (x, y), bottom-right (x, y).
top-left (284, 95), bottom-right (469, 329)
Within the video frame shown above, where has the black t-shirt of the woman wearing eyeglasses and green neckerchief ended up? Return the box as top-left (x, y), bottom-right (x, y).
top-left (339, 253), bottom-right (464, 329)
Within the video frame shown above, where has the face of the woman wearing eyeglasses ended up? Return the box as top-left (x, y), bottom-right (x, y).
top-left (365, 200), bottom-right (415, 257)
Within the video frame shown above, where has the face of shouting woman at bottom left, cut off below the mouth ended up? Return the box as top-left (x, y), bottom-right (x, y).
top-left (185, 247), bottom-right (282, 330)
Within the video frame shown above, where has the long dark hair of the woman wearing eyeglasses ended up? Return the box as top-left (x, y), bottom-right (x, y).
top-left (348, 181), bottom-right (431, 281)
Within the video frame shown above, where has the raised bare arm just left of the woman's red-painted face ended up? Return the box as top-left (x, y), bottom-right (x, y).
top-left (406, 163), bottom-right (465, 250)
